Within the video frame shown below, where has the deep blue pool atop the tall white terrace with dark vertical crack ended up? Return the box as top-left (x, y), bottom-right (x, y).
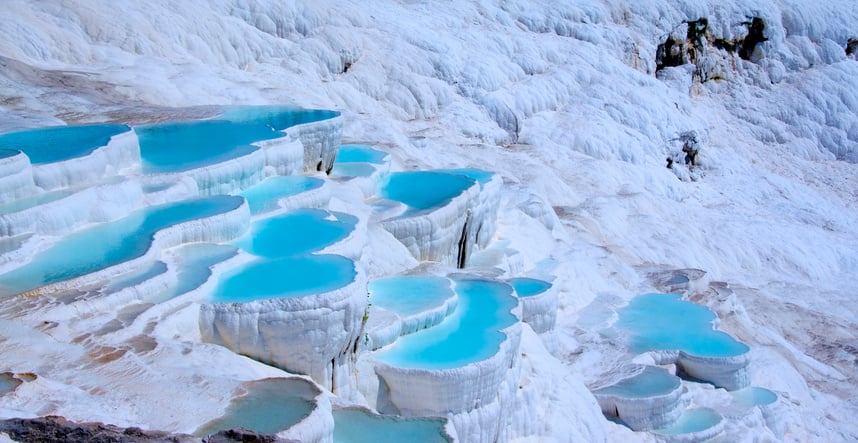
top-left (381, 171), bottom-right (475, 210)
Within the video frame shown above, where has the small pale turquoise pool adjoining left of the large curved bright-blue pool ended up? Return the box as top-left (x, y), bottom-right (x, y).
top-left (367, 275), bottom-right (455, 316)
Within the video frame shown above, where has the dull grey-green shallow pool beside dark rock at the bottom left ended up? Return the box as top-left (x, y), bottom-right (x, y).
top-left (194, 379), bottom-right (319, 437)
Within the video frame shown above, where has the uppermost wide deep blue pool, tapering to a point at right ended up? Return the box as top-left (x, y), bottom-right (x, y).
top-left (136, 106), bottom-right (339, 174)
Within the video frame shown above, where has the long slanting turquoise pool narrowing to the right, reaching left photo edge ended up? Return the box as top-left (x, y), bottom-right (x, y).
top-left (0, 195), bottom-right (244, 295)
